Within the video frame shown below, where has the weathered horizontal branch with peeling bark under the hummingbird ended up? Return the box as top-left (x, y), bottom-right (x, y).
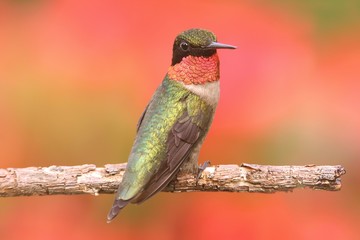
top-left (0, 164), bottom-right (345, 197)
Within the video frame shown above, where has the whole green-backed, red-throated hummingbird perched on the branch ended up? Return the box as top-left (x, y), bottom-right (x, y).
top-left (107, 29), bottom-right (236, 222)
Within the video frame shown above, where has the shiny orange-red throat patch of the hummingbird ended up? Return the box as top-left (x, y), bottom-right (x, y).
top-left (168, 53), bottom-right (220, 85)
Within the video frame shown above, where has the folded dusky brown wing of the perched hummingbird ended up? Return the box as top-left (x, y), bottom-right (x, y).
top-left (133, 111), bottom-right (204, 203)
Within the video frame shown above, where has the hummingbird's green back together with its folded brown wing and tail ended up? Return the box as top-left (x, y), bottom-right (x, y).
top-left (108, 78), bottom-right (214, 220)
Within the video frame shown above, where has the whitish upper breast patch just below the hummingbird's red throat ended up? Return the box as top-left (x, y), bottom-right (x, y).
top-left (183, 81), bottom-right (220, 107)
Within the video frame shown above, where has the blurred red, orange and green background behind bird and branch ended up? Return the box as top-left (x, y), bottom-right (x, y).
top-left (0, 0), bottom-right (360, 240)
